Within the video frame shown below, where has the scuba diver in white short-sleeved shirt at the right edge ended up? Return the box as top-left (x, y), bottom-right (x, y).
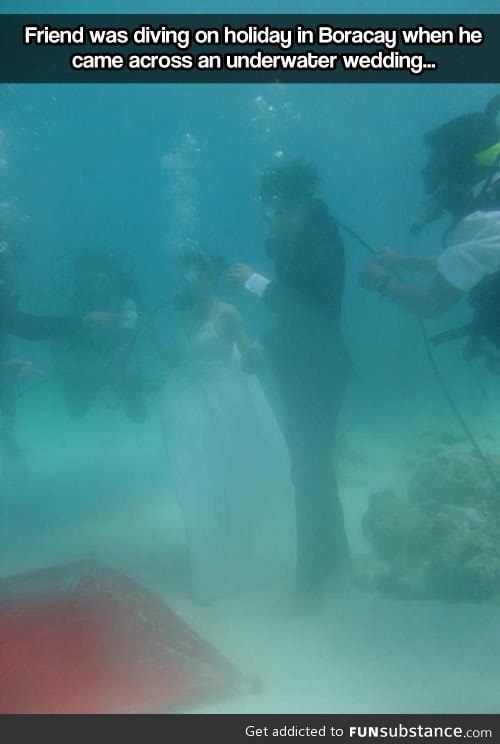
top-left (359, 95), bottom-right (500, 371)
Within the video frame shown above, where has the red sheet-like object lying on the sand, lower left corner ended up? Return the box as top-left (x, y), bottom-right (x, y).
top-left (0, 562), bottom-right (245, 713)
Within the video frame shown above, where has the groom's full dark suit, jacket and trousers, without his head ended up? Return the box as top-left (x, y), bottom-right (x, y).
top-left (263, 200), bottom-right (350, 591)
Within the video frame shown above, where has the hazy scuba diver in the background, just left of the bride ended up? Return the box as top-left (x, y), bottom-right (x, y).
top-left (54, 252), bottom-right (146, 422)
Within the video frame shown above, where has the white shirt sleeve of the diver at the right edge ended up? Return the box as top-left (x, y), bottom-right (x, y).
top-left (437, 211), bottom-right (500, 292)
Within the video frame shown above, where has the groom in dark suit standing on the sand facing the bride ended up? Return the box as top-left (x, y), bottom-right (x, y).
top-left (228, 160), bottom-right (351, 612)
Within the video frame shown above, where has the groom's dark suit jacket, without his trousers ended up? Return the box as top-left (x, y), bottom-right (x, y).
top-left (263, 199), bottom-right (349, 388)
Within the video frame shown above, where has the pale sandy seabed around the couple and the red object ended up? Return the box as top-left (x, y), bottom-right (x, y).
top-left (0, 392), bottom-right (500, 713)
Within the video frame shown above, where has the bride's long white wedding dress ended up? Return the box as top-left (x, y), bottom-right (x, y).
top-left (163, 321), bottom-right (295, 600)
